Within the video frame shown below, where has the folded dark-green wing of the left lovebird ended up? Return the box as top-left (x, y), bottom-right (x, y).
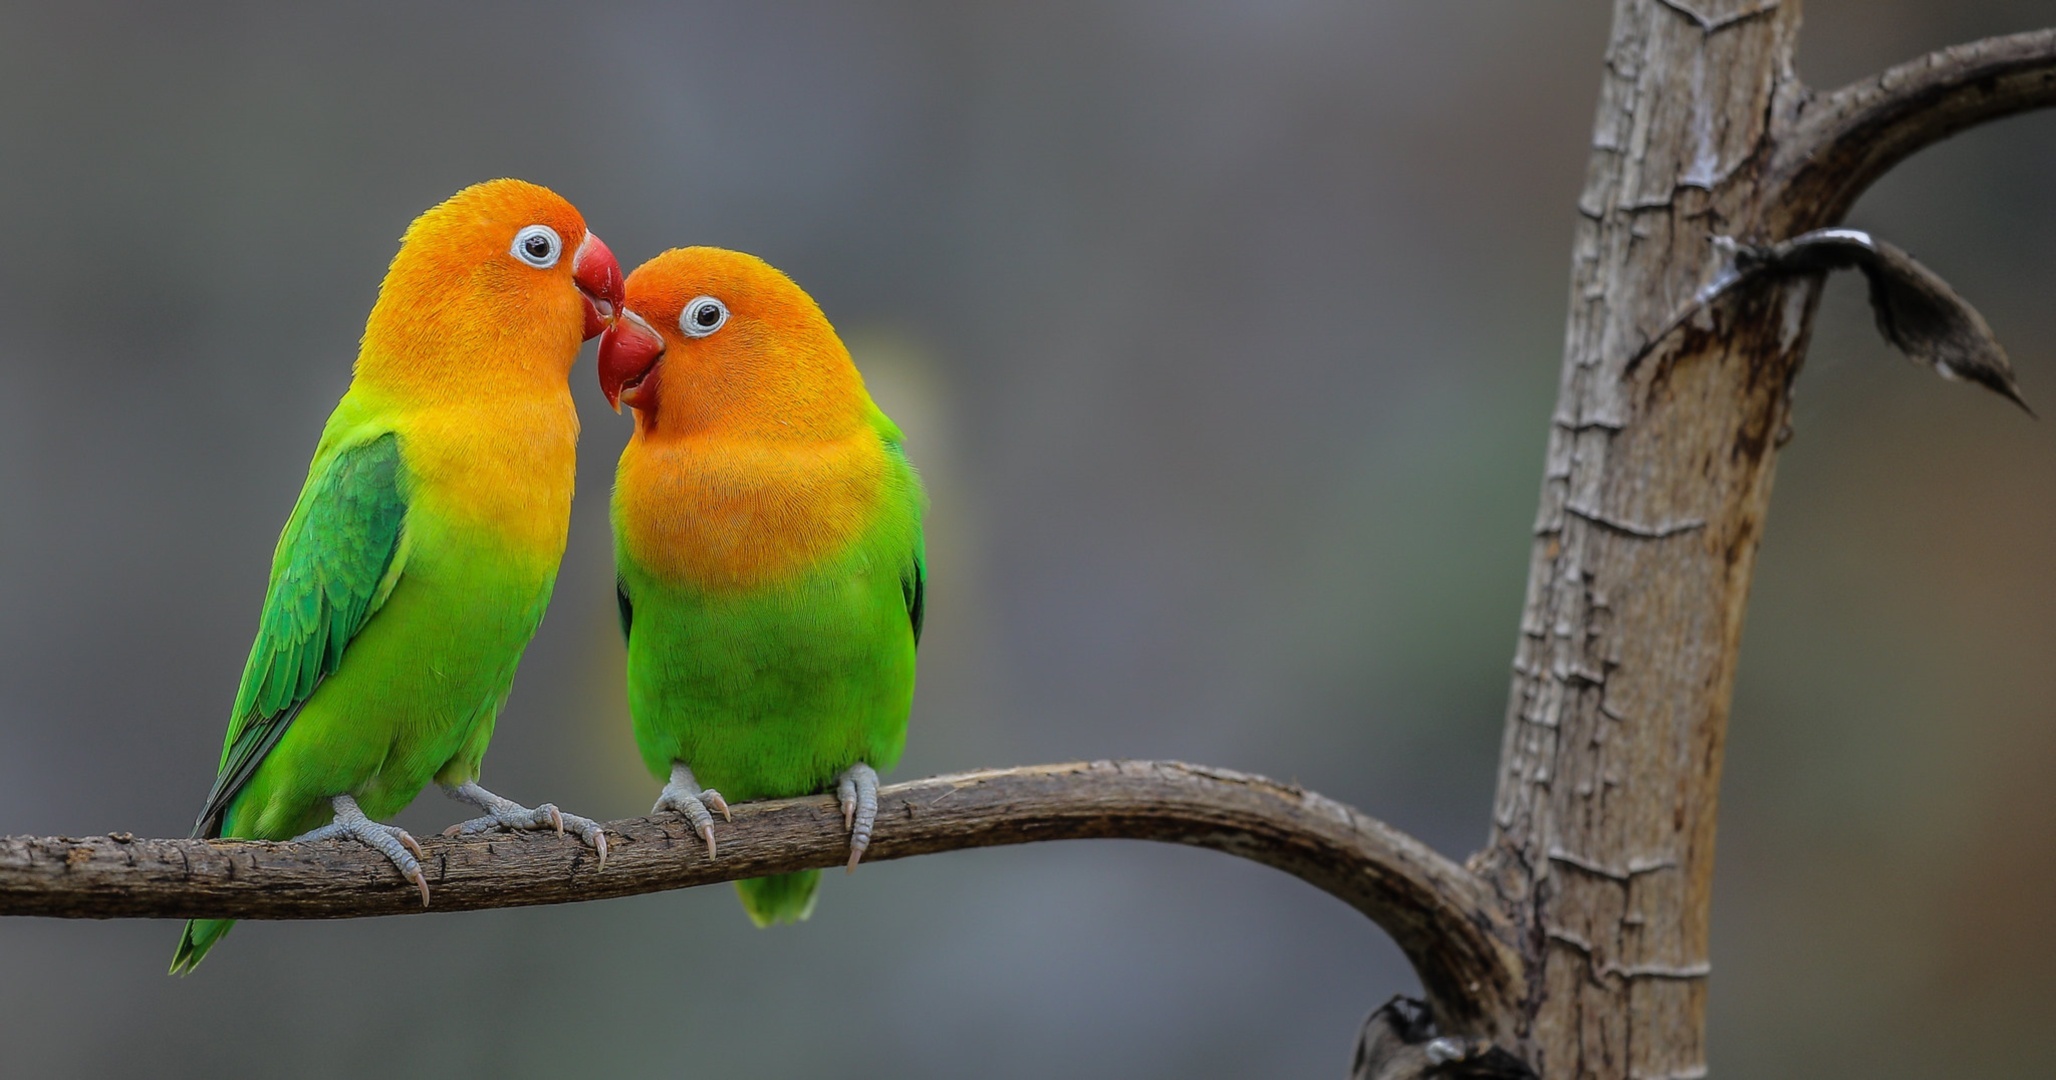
top-left (193, 432), bottom-right (407, 837)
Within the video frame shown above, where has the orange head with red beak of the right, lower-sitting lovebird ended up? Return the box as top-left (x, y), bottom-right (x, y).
top-left (598, 247), bottom-right (870, 440)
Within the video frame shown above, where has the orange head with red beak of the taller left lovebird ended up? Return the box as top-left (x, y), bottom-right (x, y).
top-left (358, 179), bottom-right (623, 391)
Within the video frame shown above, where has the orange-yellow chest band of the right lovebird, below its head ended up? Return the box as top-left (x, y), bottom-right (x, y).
top-left (615, 430), bottom-right (888, 590)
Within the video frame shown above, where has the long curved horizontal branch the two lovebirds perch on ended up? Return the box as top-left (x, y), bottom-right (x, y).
top-left (0, 761), bottom-right (1521, 1037)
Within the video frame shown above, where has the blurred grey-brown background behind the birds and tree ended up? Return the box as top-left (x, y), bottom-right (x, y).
top-left (0, 0), bottom-right (2056, 1078)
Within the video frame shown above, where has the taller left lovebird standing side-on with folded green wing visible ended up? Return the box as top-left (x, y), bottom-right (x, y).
top-left (171, 179), bottom-right (623, 973)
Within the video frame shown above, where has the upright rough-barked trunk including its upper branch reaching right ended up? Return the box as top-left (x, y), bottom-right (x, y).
top-left (1472, 0), bottom-right (2056, 1078)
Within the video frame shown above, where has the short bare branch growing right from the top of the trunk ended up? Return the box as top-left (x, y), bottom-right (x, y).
top-left (1764, 29), bottom-right (2056, 228)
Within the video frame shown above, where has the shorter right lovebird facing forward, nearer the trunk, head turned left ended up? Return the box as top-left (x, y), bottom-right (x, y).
top-left (598, 247), bottom-right (927, 926)
